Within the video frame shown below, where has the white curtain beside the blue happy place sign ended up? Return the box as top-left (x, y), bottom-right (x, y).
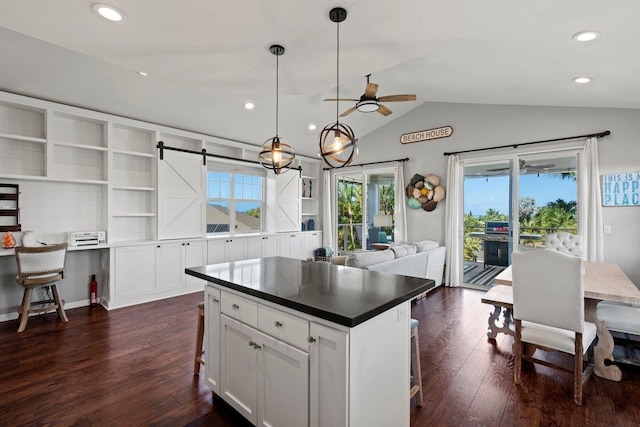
top-left (578, 138), bottom-right (604, 262)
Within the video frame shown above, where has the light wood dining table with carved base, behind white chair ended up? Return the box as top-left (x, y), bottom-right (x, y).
top-left (482, 261), bottom-right (640, 381)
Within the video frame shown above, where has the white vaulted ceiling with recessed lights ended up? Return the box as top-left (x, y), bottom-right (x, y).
top-left (0, 0), bottom-right (640, 155)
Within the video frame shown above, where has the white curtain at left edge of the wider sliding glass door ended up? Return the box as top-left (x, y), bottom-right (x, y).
top-left (444, 155), bottom-right (464, 286)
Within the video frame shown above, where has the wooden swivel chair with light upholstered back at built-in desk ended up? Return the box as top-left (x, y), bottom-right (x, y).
top-left (15, 243), bottom-right (69, 332)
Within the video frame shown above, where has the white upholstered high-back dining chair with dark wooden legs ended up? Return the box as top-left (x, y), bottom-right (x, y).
top-left (512, 250), bottom-right (596, 406)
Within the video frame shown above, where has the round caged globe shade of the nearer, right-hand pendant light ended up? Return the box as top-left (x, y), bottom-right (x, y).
top-left (319, 122), bottom-right (358, 169)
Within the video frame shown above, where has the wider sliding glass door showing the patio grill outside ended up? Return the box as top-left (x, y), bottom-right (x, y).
top-left (462, 151), bottom-right (578, 286)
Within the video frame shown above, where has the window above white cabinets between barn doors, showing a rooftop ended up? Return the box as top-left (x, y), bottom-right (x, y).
top-left (207, 171), bottom-right (264, 233)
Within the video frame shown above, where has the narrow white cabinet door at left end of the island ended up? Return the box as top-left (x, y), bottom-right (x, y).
top-left (204, 286), bottom-right (225, 394)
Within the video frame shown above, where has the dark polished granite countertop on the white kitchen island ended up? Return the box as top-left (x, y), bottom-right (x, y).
top-left (185, 257), bottom-right (435, 327)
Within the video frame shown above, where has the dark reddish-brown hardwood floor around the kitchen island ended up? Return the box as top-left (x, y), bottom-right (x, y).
top-left (0, 288), bottom-right (640, 427)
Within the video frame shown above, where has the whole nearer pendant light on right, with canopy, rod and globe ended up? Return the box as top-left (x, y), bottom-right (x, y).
top-left (318, 7), bottom-right (357, 169)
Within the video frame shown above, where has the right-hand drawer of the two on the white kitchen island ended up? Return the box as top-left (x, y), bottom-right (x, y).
top-left (258, 304), bottom-right (309, 351)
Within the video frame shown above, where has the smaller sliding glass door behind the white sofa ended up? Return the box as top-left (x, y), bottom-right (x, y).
top-left (335, 169), bottom-right (395, 253)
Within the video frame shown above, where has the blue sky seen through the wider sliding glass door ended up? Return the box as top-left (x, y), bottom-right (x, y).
top-left (464, 174), bottom-right (578, 217)
